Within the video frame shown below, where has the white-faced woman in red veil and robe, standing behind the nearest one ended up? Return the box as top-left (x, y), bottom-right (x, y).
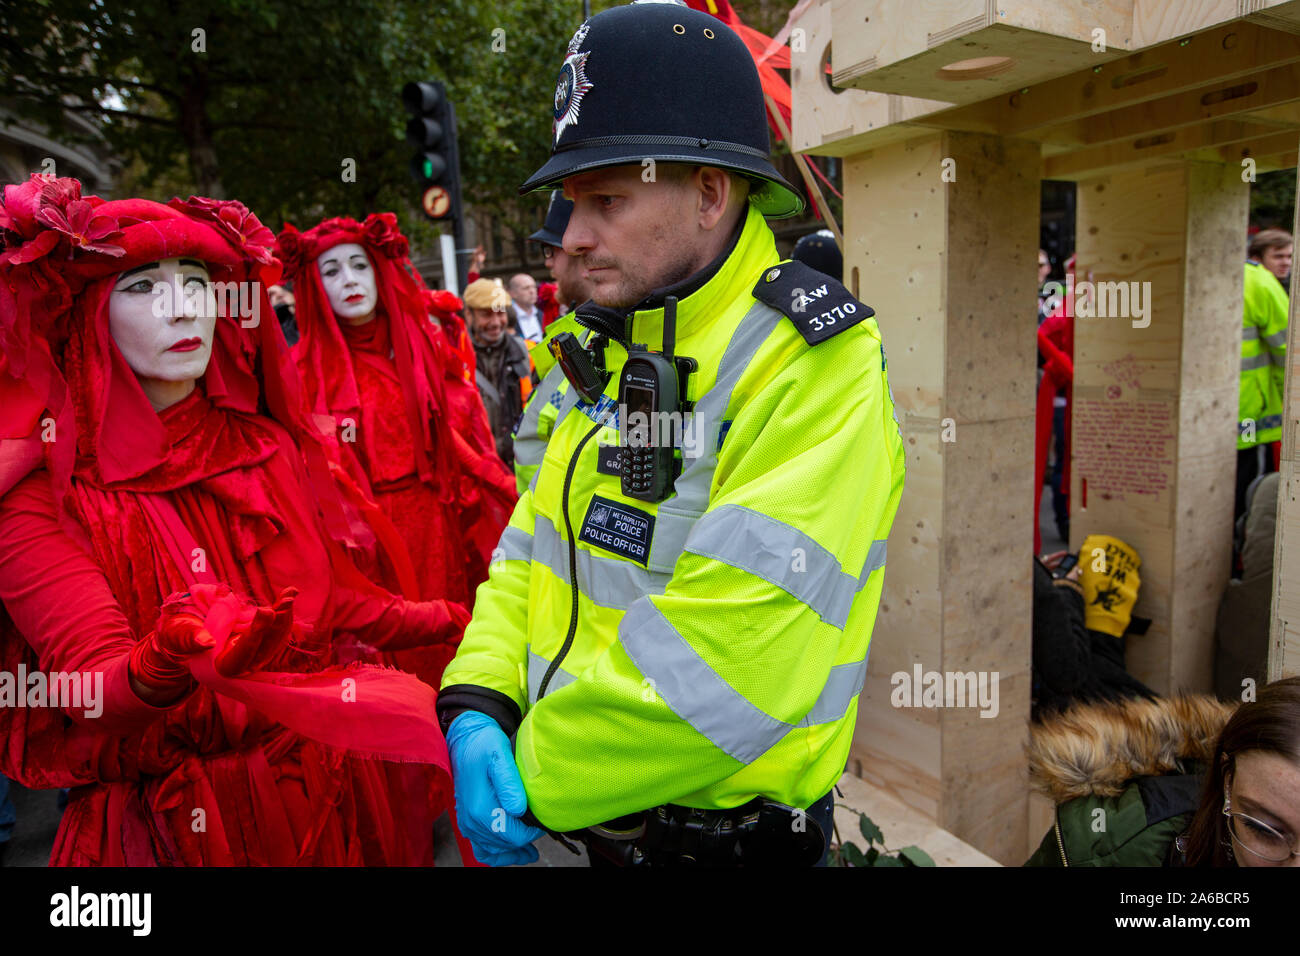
top-left (276, 213), bottom-right (517, 687)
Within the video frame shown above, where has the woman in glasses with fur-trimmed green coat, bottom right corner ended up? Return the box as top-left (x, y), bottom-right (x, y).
top-left (1026, 678), bottom-right (1300, 866)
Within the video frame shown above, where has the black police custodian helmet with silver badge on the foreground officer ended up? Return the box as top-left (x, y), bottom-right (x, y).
top-left (519, 0), bottom-right (803, 219)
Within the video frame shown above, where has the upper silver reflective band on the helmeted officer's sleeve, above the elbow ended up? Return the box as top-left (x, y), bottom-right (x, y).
top-left (686, 505), bottom-right (885, 630)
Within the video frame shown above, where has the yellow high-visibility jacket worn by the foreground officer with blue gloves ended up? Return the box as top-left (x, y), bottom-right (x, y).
top-left (438, 208), bottom-right (905, 831)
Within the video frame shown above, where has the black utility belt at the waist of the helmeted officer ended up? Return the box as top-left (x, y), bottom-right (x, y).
top-left (567, 797), bottom-right (827, 866)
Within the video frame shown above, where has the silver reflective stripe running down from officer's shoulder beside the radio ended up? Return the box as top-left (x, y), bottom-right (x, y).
top-left (649, 302), bottom-right (785, 574)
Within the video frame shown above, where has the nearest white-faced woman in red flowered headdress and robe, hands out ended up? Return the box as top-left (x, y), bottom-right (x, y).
top-left (0, 176), bottom-right (468, 865)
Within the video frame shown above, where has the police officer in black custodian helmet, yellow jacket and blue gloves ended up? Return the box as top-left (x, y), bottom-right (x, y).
top-left (438, 4), bottom-right (905, 865)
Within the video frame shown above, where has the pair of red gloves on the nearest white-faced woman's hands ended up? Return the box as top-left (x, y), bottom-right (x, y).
top-left (127, 584), bottom-right (298, 695)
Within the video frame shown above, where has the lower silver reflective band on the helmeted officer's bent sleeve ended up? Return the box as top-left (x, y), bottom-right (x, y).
top-left (619, 598), bottom-right (867, 763)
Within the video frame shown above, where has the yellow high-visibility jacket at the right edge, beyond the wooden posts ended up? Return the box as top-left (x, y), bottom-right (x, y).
top-left (1236, 263), bottom-right (1290, 449)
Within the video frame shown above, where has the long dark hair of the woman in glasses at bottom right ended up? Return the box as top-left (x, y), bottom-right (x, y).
top-left (1178, 676), bottom-right (1300, 866)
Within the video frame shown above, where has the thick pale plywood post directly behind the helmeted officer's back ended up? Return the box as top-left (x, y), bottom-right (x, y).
top-left (844, 123), bottom-right (1040, 865)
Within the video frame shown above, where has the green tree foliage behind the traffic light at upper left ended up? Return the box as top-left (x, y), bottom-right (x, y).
top-left (0, 0), bottom-right (614, 245)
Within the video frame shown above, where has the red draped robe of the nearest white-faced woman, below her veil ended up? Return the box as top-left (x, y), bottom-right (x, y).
top-left (0, 390), bottom-right (447, 865)
